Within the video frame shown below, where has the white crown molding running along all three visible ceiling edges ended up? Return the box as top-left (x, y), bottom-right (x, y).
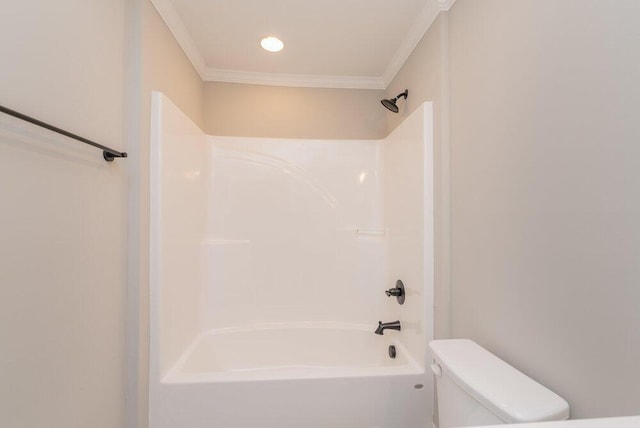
top-left (151, 0), bottom-right (456, 89)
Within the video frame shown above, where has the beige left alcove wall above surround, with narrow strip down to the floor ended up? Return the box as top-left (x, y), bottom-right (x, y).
top-left (128, 0), bottom-right (204, 427)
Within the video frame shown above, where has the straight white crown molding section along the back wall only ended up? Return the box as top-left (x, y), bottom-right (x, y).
top-left (203, 68), bottom-right (385, 89)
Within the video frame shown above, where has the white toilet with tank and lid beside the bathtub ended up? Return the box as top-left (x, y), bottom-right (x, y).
top-left (429, 339), bottom-right (569, 428)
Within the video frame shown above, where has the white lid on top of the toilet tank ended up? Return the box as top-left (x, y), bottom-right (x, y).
top-left (429, 339), bottom-right (569, 423)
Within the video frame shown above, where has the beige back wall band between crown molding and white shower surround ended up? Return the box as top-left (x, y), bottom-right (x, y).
top-left (204, 82), bottom-right (386, 139)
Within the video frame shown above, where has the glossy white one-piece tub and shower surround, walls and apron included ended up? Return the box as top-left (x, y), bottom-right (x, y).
top-left (149, 93), bottom-right (433, 428)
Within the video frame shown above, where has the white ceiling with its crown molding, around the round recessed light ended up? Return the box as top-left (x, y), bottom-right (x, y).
top-left (151, 0), bottom-right (455, 89)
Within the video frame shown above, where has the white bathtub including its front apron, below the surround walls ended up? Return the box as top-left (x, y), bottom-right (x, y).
top-left (151, 323), bottom-right (432, 428)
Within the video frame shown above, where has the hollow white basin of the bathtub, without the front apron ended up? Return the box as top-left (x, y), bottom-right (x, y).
top-left (163, 323), bottom-right (423, 383)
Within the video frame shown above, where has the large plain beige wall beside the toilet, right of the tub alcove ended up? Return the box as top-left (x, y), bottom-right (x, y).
top-left (450, 0), bottom-right (640, 417)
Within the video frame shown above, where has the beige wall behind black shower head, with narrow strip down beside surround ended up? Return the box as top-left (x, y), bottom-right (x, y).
top-left (385, 13), bottom-right (451, 338)
